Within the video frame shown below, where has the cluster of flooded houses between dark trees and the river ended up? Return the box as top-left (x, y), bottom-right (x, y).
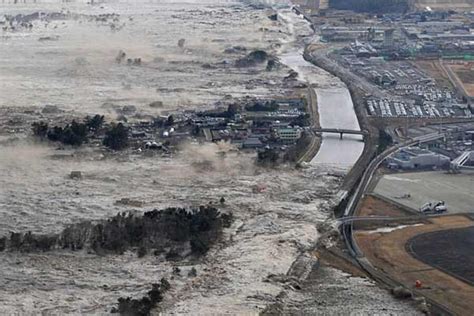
top-left (130, 98), bottom-right (310, 151)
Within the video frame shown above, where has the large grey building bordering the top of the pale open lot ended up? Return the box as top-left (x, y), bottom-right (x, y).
top-left (387, 147), bottom-right (450, 169)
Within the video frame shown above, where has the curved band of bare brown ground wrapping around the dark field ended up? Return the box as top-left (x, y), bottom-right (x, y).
top-left (355, 215), bottom-right (474, 315)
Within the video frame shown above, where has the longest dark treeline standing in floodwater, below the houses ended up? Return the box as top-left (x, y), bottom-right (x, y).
top-left (0, 206), bottom-right (232, 259)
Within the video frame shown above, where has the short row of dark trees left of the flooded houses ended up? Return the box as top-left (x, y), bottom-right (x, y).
top-left (32, 114), bottom-right (129, 150)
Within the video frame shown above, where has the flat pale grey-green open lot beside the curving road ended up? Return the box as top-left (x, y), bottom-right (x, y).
top-left (374, 171), bottom-right (474, 213)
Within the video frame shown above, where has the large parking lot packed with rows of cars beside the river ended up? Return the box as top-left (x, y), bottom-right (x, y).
top-left (339, 55), bottom-right (472, 118)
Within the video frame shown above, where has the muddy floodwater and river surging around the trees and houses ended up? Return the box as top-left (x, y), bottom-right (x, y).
top-left (0, 0), bottom-right (415, 315)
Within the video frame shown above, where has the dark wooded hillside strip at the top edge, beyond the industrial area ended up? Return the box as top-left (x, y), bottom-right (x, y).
top-left (329, 0), bottom-right (409, 13)
